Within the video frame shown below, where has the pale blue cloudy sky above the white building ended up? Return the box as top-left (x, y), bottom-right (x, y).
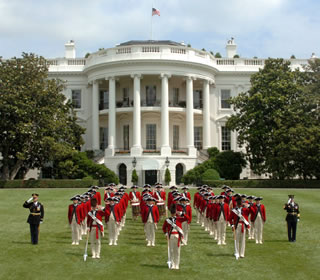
top-left (0, 0), bottom-right (320, 58)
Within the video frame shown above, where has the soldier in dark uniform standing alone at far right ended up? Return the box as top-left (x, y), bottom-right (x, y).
top-left (283, 195), bottom-right (300, 242)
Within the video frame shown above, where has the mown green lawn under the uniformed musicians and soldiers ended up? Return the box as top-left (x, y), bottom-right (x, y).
top-left (0, 189), bottom-right (320, 280)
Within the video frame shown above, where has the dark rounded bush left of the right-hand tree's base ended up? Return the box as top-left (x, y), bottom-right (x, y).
top-left (214, 151), bottom-right (246, 180)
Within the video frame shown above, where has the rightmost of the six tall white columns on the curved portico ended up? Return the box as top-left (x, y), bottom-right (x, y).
top-left (202, 80), bottom-right (211, 150)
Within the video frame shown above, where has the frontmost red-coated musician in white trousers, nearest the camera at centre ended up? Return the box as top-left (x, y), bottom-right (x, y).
top-left (162, 204), bottom-right (189, 269)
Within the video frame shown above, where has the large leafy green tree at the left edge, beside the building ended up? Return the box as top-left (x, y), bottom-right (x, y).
top-left (0, 53), bottom-right (84, 180)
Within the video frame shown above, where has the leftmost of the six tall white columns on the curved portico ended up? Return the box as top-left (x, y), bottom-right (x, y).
top-left (92, 81), bottom-right (100, 151)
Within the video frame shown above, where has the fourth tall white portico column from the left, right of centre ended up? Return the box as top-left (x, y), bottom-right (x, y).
top-left (161, 74), bottom-right (171, 156)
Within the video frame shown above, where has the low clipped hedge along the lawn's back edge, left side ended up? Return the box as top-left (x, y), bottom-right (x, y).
top-left (0, 179), bottom-right (98, 189)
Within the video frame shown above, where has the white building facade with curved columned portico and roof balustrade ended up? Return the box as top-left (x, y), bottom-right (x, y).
top-left (48, 39), bottom-right (307, 185)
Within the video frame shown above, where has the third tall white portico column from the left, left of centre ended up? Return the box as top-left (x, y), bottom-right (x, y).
top-left (131, 74), bottom-right (142, 156)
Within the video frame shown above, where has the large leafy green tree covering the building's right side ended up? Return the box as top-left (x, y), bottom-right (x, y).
top-left (227, 59), bottom-right (320, 179)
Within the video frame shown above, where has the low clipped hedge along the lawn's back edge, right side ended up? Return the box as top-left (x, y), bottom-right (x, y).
top-left (205, 179), bottom-right (320, 189)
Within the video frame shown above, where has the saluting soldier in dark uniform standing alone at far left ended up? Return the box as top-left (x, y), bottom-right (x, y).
top-left (23, 193), bottom-right (44, 245)
